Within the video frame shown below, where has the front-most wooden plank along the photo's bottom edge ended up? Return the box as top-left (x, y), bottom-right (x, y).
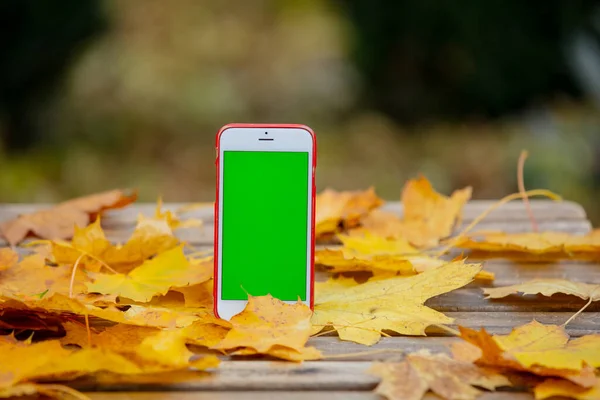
top-left (85, 391), bottom-right (533, 400)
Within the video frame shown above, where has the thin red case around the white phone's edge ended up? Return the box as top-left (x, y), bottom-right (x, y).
top-left (213, 124), bottom-right (317, 317)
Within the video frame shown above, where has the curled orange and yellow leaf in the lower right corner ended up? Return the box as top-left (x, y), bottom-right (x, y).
top-left (459, 321), bottom-right (600, 387)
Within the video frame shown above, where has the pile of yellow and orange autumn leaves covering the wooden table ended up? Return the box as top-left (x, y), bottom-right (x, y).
top-left (0, 173), bottom-right (600, 399)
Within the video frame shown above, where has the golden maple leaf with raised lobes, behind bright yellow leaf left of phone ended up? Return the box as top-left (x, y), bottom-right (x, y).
top-left (52, 217), bottom-right (179, 272)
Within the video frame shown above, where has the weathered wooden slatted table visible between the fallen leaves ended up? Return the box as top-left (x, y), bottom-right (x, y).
top-left (0, 201), bottom-right (600, 400)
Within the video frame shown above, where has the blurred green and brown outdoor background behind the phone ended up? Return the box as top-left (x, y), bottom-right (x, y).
top-left (0, 0), bottom-right (600, 223)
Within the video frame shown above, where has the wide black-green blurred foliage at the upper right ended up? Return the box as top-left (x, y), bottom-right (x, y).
top-left (342, 0), bottom-right (598, 122)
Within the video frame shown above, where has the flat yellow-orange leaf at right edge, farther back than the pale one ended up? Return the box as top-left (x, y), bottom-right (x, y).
top-left (455, 230), bottom-right (600, 260)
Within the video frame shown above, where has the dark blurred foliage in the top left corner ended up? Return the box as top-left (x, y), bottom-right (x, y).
top-left (0, 0), bottom-right (105, 149)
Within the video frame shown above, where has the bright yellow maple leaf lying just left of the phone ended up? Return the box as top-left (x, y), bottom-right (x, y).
top-left (87, 246), bottom-right (212, 302)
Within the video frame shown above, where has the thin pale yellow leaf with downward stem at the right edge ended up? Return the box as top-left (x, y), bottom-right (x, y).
top-left (483, 278), bottom-right (600, 301)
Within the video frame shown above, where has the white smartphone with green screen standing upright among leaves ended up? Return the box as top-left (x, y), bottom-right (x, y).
top-left (213, 124), bottom-right (317, 320)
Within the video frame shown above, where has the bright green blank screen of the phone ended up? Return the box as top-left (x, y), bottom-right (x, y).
top-left (221, 151), bottom-right (308, 301)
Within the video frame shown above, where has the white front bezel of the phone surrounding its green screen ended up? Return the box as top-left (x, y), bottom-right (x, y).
top-left (215, 127), bottom-right (314, 320)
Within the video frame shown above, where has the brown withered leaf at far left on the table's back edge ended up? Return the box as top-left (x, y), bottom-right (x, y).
top-left (0, 190), bottom-right (137, 245)
